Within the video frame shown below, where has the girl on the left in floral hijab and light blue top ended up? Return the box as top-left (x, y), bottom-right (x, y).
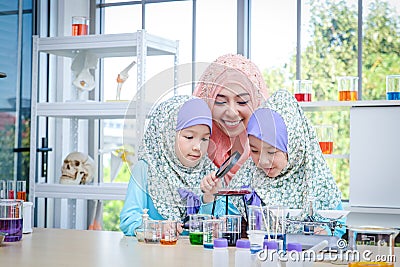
top-left (120, 96), bottom-right (216, 235)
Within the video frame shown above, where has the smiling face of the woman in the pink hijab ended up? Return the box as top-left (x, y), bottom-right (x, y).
top-left (211, 84), bottom-right (253, 137)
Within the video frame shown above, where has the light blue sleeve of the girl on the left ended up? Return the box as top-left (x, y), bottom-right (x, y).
top-left (119, 161), bottom-right (164, 236)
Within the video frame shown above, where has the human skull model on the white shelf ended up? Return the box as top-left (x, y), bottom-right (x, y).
top-left (60, 152), bottom-right (96, 184)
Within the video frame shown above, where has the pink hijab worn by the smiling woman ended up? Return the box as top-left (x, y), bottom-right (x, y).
top-left (193, 54), bottom-right (268, 184)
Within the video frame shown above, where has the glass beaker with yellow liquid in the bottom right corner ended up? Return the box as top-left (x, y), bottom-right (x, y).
top-left (349, 226), bottom-right (398, 267)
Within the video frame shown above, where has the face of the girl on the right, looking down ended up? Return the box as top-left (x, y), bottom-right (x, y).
top-left (249, 135), bottom-right (288, 178)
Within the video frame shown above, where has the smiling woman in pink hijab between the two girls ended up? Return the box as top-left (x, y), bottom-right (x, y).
top-left (193, 54), bottom-right (267, 187)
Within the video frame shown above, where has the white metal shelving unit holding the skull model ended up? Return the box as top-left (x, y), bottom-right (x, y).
top-left (29, 30), bottom-right (178, 225)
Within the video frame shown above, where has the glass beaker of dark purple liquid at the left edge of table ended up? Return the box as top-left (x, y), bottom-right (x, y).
top-left (0, 199), bottom-right (23, 242)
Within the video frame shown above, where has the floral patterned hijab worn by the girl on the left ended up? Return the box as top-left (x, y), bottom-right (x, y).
top-left (138, 96), bottom-right (215, 220)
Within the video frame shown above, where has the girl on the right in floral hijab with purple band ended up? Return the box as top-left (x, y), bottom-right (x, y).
top-left (232, 90), bottom-right (345, 239)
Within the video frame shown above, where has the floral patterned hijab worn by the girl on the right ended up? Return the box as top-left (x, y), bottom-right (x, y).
top-left (232, 90), bottom-right (341, 218)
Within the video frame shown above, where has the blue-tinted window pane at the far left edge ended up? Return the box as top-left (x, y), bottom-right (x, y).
top-left (0, 0), bottom-right (32, 199)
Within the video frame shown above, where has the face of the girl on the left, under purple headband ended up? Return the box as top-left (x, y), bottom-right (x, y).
top-left (175, 124), bottom-right (210, 167)
